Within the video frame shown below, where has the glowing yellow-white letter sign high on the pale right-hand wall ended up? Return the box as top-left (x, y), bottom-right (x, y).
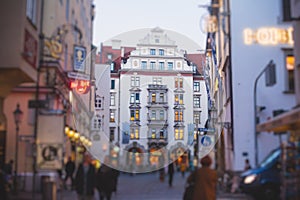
top-left (244, 27), bottom-right (294, 45)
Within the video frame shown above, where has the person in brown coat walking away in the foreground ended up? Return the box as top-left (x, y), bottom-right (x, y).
top-left (187, 155), bottom-right (217, 200)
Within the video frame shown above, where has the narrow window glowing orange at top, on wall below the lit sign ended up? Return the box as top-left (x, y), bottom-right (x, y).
top-left (285, 54), bottom-right (295, 92)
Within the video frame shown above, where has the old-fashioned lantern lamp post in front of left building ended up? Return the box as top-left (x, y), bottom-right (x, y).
top-left (13, 103), bottom-right (23, 192)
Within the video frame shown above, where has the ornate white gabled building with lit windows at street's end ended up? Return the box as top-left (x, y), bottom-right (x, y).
top-left (96, 27), bottom-right (207, 171)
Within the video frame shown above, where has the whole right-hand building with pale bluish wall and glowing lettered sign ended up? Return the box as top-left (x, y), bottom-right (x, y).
top-left (207, 0), bottom-right (295, 171)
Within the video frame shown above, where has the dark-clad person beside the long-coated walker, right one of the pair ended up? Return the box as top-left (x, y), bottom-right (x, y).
top-left (96, 164), bottom-right (117, 200)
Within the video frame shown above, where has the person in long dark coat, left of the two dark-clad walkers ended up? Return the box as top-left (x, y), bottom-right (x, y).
top-left (75, 153), bottom-right (96, 200)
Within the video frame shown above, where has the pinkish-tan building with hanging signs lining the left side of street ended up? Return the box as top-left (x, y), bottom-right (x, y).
top-left (0, 0), bottom-right (94, 191)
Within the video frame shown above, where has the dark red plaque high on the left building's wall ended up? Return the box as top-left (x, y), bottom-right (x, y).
top-left (23, 29), bottom-right (38, 68)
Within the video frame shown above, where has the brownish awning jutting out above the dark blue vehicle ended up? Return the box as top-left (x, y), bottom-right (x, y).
top-left (256, 107), bottom-right (300, 132)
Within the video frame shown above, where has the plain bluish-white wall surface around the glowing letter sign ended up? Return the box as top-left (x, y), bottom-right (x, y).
top-left (231, 0), bottom-right (295, 170)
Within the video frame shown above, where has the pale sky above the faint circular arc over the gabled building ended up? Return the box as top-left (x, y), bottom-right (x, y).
top-left (93, 0), bottom-right (209, 49)
